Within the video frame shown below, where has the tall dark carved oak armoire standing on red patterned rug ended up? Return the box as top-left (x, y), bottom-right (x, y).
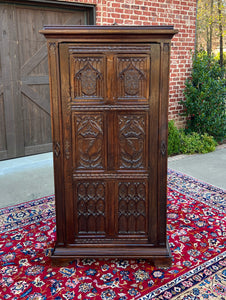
top-left (41, 26), bottom-right (177, 265)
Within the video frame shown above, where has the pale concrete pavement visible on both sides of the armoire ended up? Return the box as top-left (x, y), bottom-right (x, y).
top-left (0, 145), bottom-right (226, 207)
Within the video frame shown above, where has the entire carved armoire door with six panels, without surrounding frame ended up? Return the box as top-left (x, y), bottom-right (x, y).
top-left (60, 44), bottom-right (157, 243)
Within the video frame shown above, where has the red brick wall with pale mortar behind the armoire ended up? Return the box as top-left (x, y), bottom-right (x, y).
top-left (65, 0), bottom-right (196, 127)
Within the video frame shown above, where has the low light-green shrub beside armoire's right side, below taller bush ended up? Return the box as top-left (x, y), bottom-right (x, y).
top-left (168, 120), bottom-right (217, 156)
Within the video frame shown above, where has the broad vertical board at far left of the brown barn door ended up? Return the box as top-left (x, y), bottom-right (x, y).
top-left (1, 6), bottom-right (24, 158)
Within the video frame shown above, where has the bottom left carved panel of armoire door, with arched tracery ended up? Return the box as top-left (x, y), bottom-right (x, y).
top-left (77, 182), bottom-right (105, 234)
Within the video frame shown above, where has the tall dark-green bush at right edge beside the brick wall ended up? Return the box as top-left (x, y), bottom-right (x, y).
top-left (180, 51), bottom-right (226, 141)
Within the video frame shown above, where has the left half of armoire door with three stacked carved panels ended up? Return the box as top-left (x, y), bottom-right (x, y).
top-left (60, 44), bottom-right (108, 243)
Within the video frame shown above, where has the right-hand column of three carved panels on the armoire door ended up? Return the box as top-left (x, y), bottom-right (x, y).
top-left (113, 53), bottom-right (150, 242)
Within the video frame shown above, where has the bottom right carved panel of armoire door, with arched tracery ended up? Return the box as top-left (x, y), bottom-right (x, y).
top-left (118, 182), bottom-right (146, 234)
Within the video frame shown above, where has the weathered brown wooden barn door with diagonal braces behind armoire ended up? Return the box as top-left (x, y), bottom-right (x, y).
top-left (0, 1), bottom-right (93, 159)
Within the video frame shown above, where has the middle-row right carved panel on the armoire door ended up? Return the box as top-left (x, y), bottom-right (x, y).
top-left (118, 115), bottom-right (146, 169)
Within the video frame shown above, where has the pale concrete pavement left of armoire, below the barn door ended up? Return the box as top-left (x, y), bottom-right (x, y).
top-left (0, 152), bottom-right (54, 207)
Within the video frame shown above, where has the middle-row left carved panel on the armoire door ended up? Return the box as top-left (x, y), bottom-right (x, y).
top-left (76, 114), bottom-right (104, 169)
